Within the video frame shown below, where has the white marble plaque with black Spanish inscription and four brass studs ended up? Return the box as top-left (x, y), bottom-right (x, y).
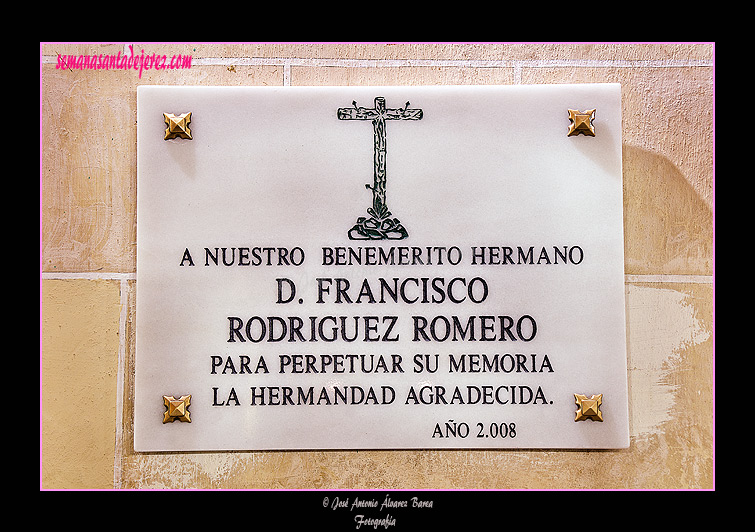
top-left (134, 84), bottom-right (629, 451)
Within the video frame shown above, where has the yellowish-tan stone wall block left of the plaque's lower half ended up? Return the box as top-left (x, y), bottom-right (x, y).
top-left (40, 280), bottom-right (120, 488)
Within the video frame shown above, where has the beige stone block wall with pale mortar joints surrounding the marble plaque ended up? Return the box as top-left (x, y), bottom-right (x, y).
top-left (40, 43), bottom-right (715, 489)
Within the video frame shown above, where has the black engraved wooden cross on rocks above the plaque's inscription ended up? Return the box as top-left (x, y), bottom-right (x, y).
top-left (338, 96), bottom-right (422, 240)
